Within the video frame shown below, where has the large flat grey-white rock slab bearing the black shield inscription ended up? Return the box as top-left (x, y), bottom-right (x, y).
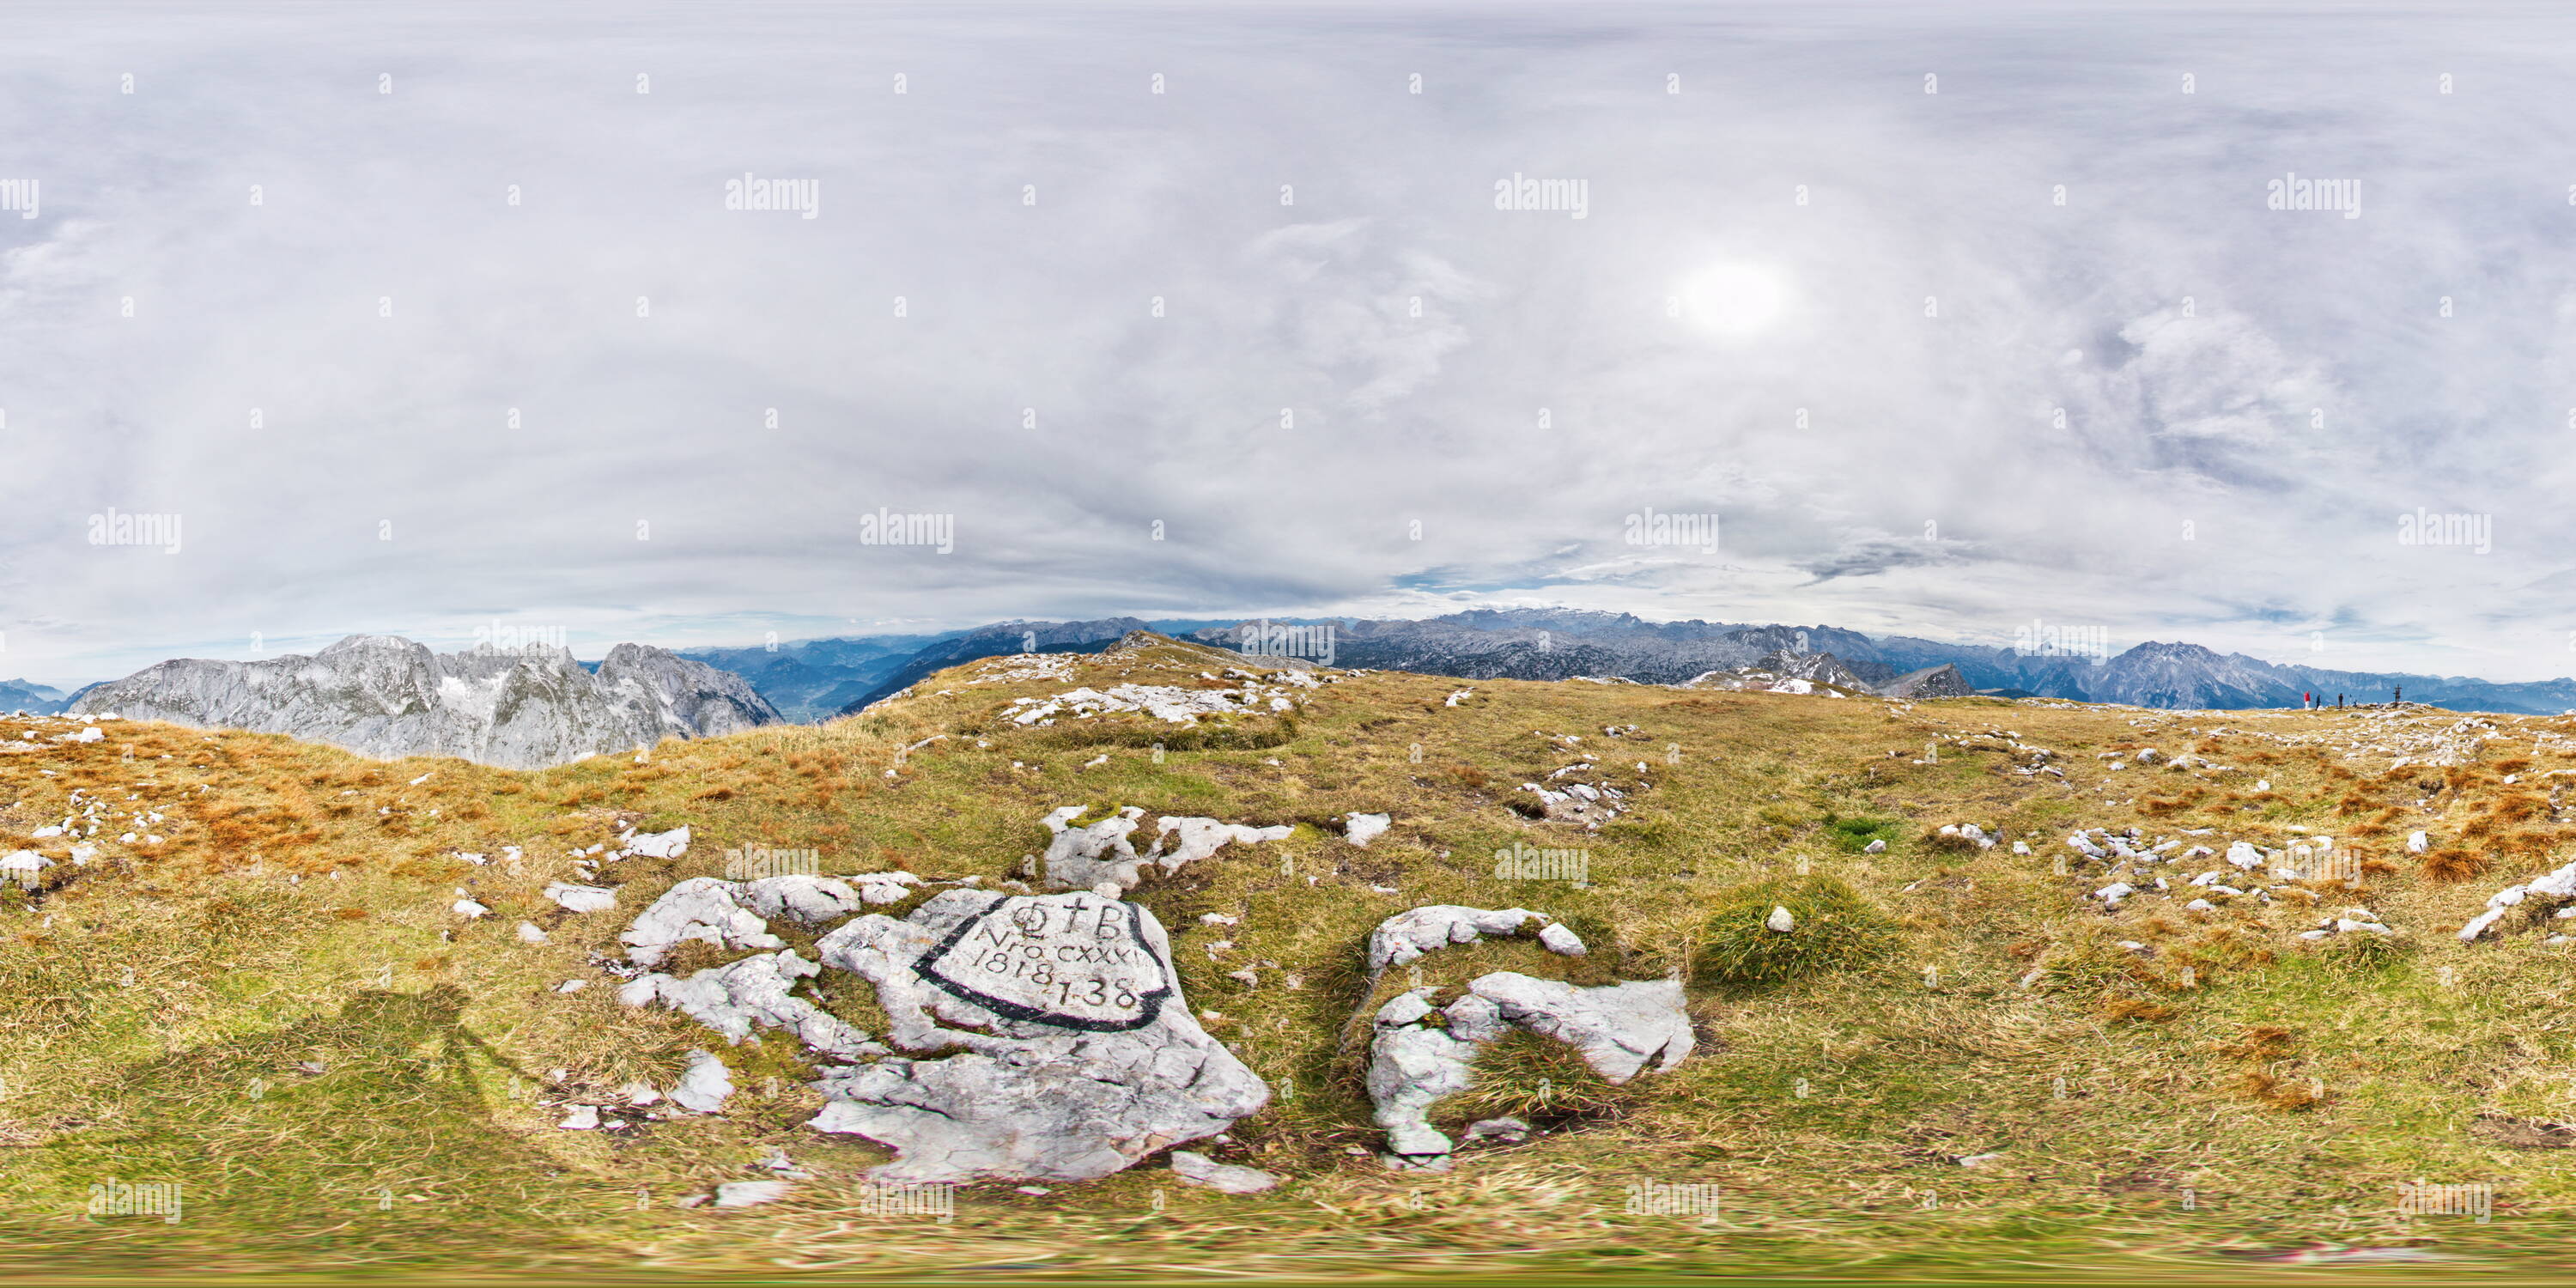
top-left (809, 889), bottom-right (1270, 1182)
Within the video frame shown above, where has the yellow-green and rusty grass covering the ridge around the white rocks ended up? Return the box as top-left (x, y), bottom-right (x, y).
top-left (0, 644), bottom-right (2576, 1278)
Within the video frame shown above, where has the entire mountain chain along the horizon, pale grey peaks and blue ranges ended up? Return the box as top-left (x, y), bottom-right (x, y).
top-left (60, 608), bottom-right (2576, 768)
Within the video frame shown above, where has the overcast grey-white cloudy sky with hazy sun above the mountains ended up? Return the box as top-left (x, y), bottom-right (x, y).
top-left (0, 3), bottom-right (2576, 683)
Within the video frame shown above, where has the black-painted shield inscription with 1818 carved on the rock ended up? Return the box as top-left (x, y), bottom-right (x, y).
top-left (914, 891), bottom-right (1172, 1033)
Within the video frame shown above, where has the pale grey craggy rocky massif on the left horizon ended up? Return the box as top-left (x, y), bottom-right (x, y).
top-left (67, 636), bottom-right (783, 770)
